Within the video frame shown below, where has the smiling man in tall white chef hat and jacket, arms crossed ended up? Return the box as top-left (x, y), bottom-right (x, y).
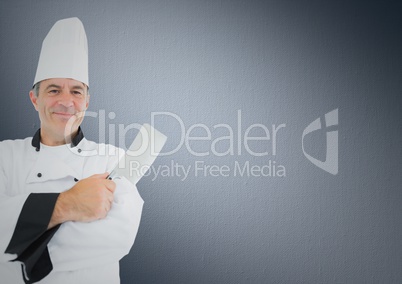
top-left (0, 18), bottom-right (143, 284)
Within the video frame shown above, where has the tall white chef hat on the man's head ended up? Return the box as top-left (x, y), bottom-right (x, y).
top-left (34, 18), bottom-right (89, 86)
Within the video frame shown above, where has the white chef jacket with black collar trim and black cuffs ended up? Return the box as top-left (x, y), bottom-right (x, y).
top-left (0, 130), bottom-right (143, 284)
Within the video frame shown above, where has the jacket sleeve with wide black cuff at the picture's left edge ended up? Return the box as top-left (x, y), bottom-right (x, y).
top-left (0, 156), bottom-right (58, 283)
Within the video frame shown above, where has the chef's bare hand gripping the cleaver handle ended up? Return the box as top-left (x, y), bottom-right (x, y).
top-left (48, 173), bottom-right (116, 228)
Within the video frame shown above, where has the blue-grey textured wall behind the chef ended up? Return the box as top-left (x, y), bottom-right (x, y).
top-left (0, 0), bottom-right (402, 283)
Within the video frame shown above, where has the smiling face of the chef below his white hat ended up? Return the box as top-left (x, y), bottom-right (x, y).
top-left (29, 78), bottom-right (89, 141)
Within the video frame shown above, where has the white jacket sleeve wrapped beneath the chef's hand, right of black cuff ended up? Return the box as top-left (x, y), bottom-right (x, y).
top-left (48, 178), bottom-right (144, 271)
